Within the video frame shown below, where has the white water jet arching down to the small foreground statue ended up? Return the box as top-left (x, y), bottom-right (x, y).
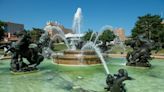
top-left (81, 42), bottom-right (109, 74)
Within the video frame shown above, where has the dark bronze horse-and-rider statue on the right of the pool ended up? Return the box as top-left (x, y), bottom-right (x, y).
top-left (126, 35), bottom-right (154, 67)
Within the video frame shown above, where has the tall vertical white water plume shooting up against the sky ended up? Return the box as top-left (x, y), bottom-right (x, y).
top-left (72, 8), bottom-right (82, 34)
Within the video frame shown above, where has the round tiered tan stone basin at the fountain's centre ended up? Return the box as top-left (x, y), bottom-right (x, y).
top-left (53, 50), bottom-right (101, 65)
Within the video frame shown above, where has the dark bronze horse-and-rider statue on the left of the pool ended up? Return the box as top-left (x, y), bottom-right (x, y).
top-left (8, 32), bottom-right (44, 72)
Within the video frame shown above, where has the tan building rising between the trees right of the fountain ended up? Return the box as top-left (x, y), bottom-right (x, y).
top-left (114, 28), bottom-right (126, 43)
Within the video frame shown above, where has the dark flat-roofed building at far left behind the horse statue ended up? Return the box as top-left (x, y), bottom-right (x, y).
top-left (5, 22), bottom-right (24, 34)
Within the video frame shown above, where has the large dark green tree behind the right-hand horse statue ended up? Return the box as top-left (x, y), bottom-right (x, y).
top-left (132, 14), bottom-right (164, 42)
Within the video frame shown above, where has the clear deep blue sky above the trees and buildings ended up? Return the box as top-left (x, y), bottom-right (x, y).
top-left (0, 0), bottom-right (164, 36)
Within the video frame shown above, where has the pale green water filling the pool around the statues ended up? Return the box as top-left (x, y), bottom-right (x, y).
top-left (0, 58), bottom-right (164, 92)
